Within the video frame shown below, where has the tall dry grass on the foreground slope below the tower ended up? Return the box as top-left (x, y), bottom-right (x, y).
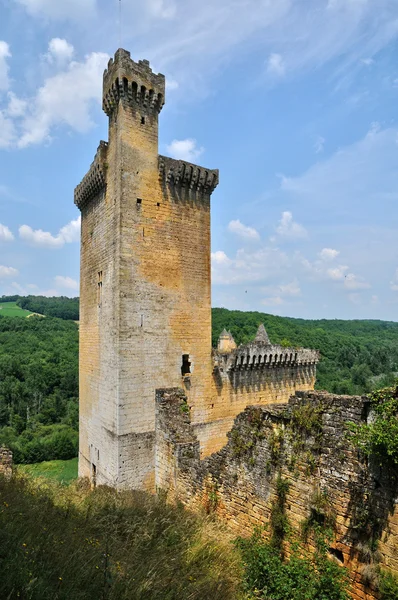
top-left (0, 474), bottom-right (242, 600)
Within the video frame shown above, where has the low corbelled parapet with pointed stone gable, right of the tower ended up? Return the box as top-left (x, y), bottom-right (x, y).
top-left (214, 325), bottom-right (319, 373)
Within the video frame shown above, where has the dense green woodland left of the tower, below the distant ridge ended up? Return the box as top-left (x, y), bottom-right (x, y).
top-left (0, 316), bottom-right (79, 463)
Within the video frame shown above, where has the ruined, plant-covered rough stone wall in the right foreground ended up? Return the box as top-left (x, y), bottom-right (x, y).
top-left (157, 390), bottom-right (398, 600)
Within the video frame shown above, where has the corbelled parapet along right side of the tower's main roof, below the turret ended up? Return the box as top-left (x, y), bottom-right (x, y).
top-left (159, 156), bottom-right (219, 194)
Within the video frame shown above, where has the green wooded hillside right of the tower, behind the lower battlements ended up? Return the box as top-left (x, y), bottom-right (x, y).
top-left (212, 308), bottom-right (398, 394)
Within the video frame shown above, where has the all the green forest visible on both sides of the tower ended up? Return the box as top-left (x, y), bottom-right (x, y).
top-left (0, 296), bottom-right (398, 463)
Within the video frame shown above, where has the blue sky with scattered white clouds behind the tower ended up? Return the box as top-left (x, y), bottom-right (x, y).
top-left (0, 0), bottom-right (398, 320)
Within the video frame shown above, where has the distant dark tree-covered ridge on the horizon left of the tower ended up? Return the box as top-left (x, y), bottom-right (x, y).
top-left (0, 296), bottom-right (79, 321)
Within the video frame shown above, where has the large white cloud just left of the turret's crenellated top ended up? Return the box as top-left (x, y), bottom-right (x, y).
top-left (18, 52), bottom-right (109, 148)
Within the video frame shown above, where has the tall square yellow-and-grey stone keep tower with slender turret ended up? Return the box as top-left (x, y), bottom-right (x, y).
top-left (75, 49), bottom-right (218, 490)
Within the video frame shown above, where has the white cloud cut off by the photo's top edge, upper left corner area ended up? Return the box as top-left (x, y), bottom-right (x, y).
top-left (16, 0), bottom-right (96, 20)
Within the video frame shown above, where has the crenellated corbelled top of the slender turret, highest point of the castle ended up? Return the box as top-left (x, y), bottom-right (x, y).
top-left (102, 48), bottom-right (166, 117)
